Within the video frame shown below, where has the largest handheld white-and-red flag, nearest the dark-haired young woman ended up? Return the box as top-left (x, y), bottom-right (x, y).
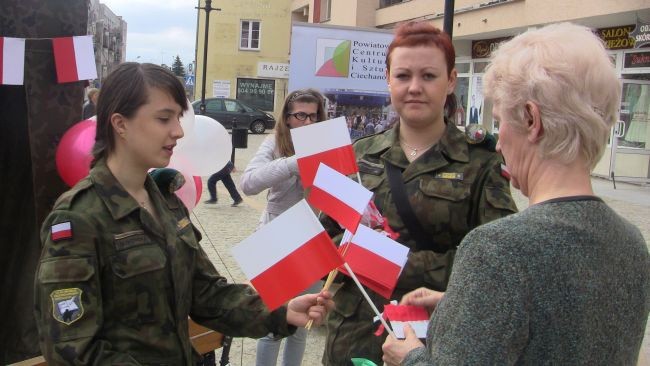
top-left (232, 200), bottom-right (343, 310)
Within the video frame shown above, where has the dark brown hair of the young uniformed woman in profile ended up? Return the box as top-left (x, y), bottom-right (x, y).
top-left (91, 62), bottom-right (188, 167)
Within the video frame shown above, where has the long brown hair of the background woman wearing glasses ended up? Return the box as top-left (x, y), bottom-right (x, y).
top-left (275, 88), bottom-right (327, 157)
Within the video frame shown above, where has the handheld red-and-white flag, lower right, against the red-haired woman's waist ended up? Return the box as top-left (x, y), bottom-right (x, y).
top-left (339, 225), bottom-right (409, 299)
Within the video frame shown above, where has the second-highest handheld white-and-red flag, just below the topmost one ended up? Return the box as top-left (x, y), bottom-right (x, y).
top-left (307, 163), bottom-right (372, 233)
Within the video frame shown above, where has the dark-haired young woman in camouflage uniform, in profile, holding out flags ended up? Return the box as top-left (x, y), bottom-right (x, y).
top-left (35, 63), bottom-right (333, 365)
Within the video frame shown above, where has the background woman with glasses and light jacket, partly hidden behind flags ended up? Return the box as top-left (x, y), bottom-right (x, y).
top-left (240, 89), bottom-right (327, 366)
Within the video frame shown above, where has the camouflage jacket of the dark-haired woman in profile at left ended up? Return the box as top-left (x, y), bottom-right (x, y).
top-left (35, 162), bottom-right (295, 365)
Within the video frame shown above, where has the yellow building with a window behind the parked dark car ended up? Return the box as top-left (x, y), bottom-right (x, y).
top-left (194, 0), bottom-right (291, 119)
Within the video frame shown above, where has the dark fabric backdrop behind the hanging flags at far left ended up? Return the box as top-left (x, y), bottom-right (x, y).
top-left (0, 0), bottom-right (88, 365)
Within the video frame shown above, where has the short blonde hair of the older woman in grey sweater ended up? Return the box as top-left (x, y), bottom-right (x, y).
top-left (483, 23), bottom-right (621, 169)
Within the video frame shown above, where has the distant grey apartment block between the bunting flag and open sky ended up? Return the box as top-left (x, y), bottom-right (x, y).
top-left (88, 0), bottom-right (127, 87)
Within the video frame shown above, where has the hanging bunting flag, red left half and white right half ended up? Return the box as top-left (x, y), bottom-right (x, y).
top-left (52, 36), bottom-right (97, 84)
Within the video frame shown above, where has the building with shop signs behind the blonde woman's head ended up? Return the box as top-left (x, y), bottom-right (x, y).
top-left (291, 0), bottom-right (650, 183)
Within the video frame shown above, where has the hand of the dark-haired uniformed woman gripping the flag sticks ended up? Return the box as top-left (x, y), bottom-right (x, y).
top-left (287, 291), bottom-right (334, 327)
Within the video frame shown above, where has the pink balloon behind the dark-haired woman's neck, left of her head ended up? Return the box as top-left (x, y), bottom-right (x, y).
top-left (56, 119), bottom-right (97, 187)
